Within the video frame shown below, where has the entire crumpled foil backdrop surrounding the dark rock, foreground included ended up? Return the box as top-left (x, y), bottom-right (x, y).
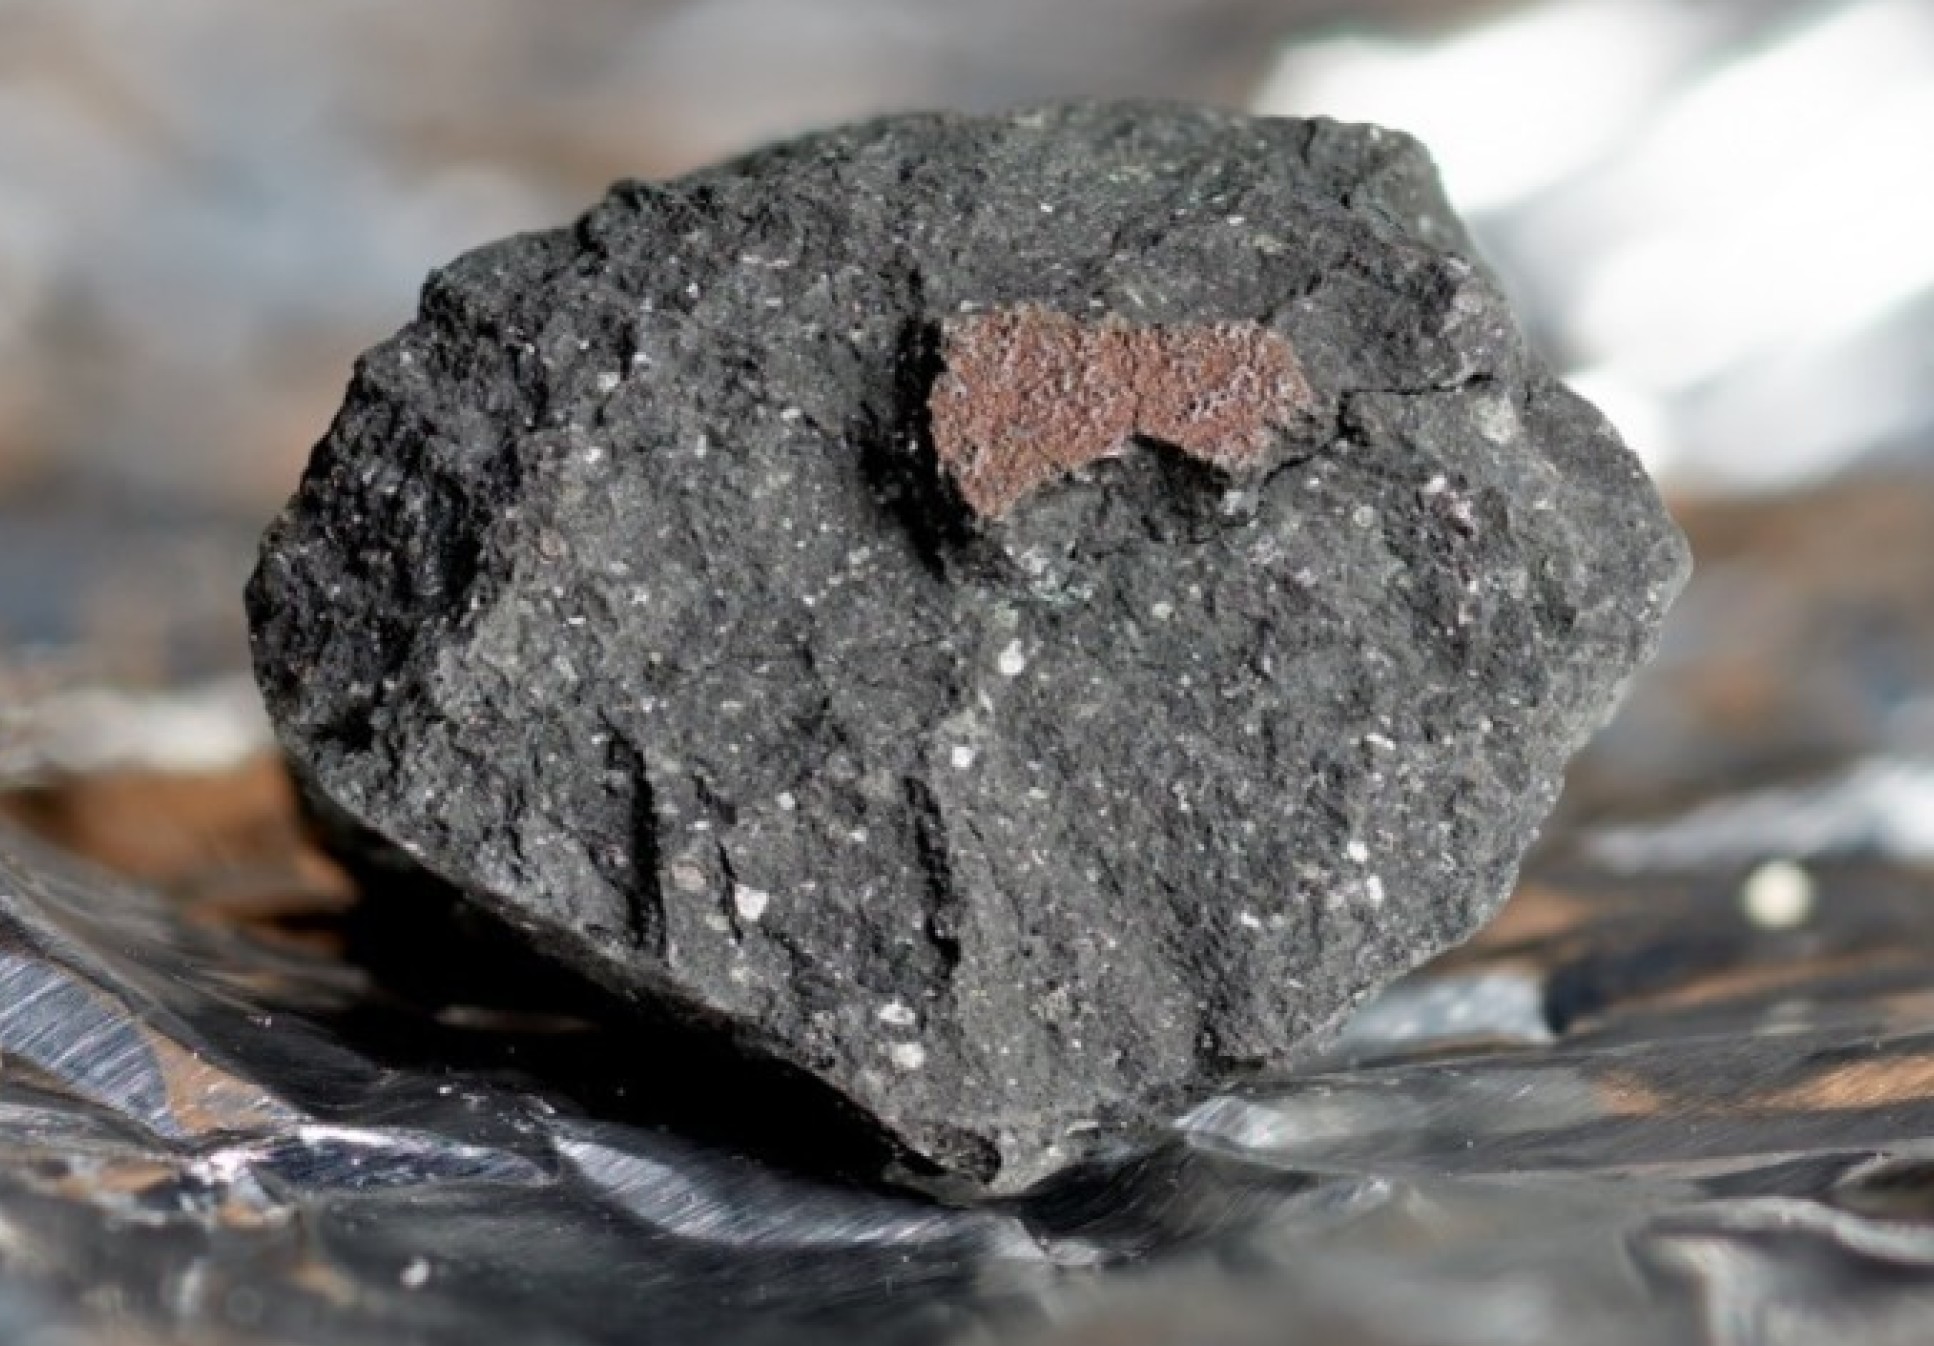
top-left (0, 0), bottom-right (1934, 1346)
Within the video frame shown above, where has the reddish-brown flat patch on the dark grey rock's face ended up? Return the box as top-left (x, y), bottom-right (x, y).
top-left (928, 304), bottom-right (1313, 518)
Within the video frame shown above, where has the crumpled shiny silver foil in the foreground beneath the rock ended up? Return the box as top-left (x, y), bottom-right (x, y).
top-left (0, 808), bottom-right (1934, 1346)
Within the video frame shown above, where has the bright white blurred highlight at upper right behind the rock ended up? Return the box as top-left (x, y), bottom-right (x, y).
top-left (1259, 0), bottom-right (1934, 493)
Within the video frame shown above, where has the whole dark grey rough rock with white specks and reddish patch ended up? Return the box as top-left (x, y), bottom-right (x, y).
top-left (249, 104), bottom-right (1686, 1189)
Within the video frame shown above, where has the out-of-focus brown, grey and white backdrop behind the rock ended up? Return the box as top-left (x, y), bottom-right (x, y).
top-left (0, 0), bottom-right (1934, 874)
